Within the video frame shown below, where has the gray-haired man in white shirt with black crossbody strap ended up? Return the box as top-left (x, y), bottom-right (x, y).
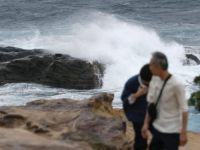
top-left (141, 52), bottom-right (188, 150)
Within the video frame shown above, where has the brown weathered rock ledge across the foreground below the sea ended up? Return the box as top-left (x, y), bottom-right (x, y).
top-left (0, 93), bottom-right (200, 150)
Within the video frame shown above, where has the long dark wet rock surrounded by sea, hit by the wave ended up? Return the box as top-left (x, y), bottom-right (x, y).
top-left (0, 47), bottom-right (105, 89)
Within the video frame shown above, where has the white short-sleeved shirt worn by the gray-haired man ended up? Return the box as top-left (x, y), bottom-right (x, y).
top-left (147, 75), bottom-right (188, 133)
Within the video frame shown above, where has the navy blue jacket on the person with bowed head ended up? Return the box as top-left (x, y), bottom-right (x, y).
top-left (121, 75), bottom-right (147, 123)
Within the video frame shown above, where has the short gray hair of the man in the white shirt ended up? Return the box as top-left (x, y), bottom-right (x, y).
top-left (153, 52), bottom-right (168, 70)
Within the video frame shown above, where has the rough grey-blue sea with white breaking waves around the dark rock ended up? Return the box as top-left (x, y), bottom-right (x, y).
top-left (0, 0), bottom-right (200, 132)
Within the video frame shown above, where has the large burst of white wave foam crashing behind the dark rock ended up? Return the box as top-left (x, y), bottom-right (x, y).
top-left (40, 13), bottom-right (198, 94)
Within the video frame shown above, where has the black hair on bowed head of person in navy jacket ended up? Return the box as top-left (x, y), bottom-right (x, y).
top-left (140, 64), bottom-right (152, 82)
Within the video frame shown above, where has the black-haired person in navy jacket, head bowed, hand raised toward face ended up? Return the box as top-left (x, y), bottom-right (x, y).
top-left (121, 64), bottom-right (152, 150)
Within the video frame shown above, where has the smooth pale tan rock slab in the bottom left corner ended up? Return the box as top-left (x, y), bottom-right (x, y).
top-left (0, 128), bottom-right (92, 150)
